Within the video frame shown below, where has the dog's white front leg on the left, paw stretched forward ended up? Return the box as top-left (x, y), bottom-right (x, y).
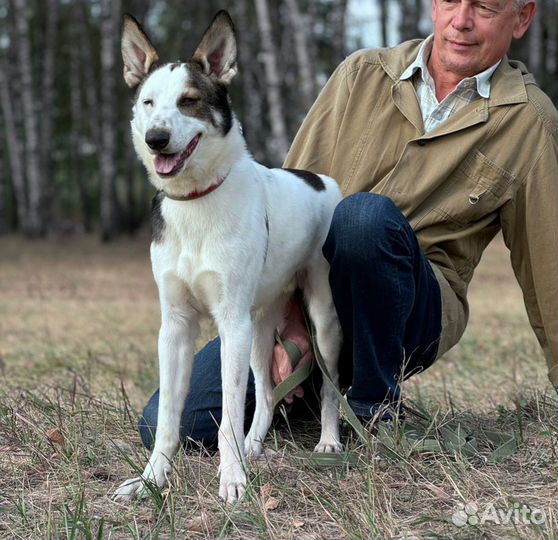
top-left (113, 301), bottom-right (199, 500)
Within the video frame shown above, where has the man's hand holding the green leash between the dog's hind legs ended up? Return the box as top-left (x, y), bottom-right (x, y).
top-left (271, 296), bottom-right (313, 403)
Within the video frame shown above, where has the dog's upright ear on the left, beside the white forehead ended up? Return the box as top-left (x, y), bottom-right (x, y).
top-left (121, 14), bottom-right (159, 88)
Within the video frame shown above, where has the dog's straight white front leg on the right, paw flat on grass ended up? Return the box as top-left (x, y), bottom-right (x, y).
top-left (217, 312), bottom-right (252, 503)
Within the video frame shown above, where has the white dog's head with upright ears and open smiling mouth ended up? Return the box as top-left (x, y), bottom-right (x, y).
top-left (122, 11), bottom-right (237, 189)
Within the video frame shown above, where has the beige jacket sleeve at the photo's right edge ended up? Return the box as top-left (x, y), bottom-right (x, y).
top-left (500, 130), bottom-right (558, 390)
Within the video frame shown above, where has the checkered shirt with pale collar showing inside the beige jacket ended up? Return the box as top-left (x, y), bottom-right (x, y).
top-left (400, 34), bottom-right (500, 133)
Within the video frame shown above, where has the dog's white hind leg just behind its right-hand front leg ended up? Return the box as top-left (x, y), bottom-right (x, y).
top-left (244, 294), bottom-right (288, 457)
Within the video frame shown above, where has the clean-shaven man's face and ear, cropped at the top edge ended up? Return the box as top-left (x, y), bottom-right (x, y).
top-left (432, 0), bottom-right (535, 78)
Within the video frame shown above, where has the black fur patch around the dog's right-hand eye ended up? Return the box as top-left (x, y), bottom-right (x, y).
top-left (179, 61), bottom-right (233, 137)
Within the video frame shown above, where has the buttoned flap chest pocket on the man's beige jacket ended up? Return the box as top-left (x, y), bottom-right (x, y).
top-left (435, 150), bottom-right (516, 226)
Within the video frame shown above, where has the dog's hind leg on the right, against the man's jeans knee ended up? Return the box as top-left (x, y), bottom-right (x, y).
top-left (302, 260), bottom-right (343, 452)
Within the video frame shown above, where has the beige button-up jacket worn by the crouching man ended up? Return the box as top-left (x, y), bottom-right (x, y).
top-left (286, 40), bottom-right (558, 387)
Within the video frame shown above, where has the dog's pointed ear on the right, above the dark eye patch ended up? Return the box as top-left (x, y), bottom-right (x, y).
top-left (192, 10), bottom-right (238, 84)
